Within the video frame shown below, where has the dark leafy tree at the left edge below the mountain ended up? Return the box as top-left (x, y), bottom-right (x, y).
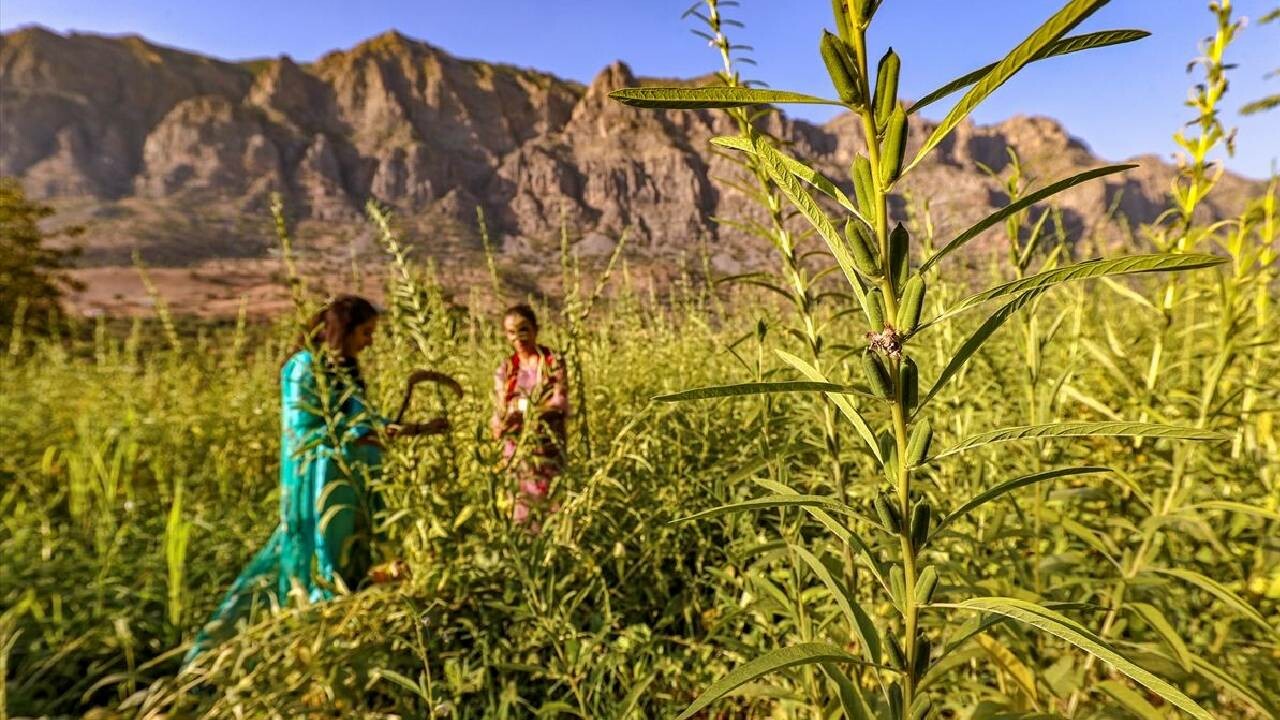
top-left (0, 178), bottom-right (84, 332)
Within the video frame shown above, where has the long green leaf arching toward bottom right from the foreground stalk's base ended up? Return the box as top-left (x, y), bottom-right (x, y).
top-left (943, 597), bottom-right (1213, 720)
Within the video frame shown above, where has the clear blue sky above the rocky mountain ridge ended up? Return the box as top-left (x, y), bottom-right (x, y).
top-left (0, 0), bottom-right (1280, 177)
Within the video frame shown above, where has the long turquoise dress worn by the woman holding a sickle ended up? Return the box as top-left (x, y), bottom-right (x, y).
top-left (183, 350), bottom-right (385, 665)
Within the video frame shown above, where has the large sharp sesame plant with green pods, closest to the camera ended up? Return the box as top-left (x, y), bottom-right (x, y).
top-left (612, 0), bottom-right (1266, 720)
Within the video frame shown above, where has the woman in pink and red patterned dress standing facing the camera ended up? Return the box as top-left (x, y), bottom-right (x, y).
top-left (489, 305), bottom-right (568, 532)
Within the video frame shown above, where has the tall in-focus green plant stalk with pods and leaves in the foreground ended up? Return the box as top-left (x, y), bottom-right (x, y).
top-left (612, 0), bottom-right (1244, 720)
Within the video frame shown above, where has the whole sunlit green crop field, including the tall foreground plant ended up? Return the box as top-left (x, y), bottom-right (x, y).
top-left (0, 0), bottom-right (1280, 720)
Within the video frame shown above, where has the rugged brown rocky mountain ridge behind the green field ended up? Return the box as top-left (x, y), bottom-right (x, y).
top-left (0, 28), bottom-right (1249, 312)
